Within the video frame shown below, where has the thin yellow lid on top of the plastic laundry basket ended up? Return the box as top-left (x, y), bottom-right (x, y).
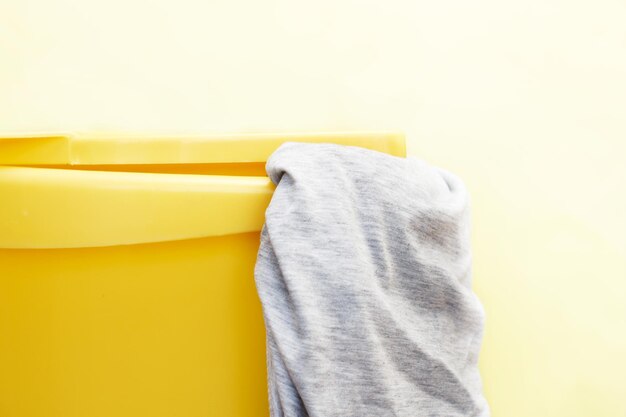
top-left (0, 132), bottom-right (406, 165)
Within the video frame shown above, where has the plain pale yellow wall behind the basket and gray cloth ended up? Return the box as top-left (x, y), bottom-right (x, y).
top-left (0, 0), bottom-right (626, 417)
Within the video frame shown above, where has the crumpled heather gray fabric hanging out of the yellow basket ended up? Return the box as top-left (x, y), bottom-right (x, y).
top-left (255, 142), bottom-right (489, 417)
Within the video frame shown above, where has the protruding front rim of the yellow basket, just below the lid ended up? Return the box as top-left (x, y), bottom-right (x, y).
top-left (0, 166), bottom-right (274, 248)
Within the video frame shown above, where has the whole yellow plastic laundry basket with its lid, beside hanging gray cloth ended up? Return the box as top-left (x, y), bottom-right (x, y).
top-left (0, 133), bottom-right (405, 417)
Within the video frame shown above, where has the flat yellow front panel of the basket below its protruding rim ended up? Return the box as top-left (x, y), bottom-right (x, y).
top-left (0, 232), bottom-right (267, 417)
